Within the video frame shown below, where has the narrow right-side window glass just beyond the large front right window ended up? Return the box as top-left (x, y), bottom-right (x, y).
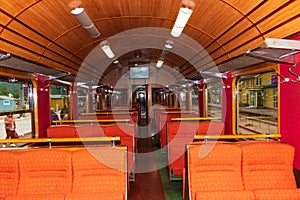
top-left (207, 81), bottom-right (222, 119)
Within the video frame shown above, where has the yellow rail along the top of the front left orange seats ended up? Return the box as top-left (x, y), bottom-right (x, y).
top-left (0, 136), bottom-right (121, 148)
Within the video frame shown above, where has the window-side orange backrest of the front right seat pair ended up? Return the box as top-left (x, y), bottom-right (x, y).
top-left (241, 142), bottom-right (296, 190)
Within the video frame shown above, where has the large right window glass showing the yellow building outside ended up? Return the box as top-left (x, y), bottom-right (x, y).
top-left (236, 72), bottom-right (278, 134)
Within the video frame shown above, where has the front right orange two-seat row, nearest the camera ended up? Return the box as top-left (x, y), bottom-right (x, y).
top-left (184, 142), bottom-right (300, 200)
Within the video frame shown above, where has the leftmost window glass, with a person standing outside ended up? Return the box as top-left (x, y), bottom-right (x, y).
top-left (0, 78), bottom-right (34, 139)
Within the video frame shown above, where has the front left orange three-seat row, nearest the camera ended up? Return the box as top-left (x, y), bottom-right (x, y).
top-left (0, 147), bottom-right (128, 200)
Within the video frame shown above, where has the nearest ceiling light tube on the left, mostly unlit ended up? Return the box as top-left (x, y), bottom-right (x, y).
top-left (71, 8), bottom-right (100, 38)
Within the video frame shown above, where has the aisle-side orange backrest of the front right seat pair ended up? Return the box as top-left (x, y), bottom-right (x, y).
top-left (188, 143), bottom-right (244, 199)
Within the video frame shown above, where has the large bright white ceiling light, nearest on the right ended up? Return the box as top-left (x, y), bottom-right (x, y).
top-left (171, 1), bottom-right (194, 37)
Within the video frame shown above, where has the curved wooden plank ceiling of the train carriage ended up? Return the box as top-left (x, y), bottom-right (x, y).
top-left (0, 0), bottom-right (300, 85)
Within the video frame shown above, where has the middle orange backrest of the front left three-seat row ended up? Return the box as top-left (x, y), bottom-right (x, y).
top-left (18, 149), bottom-right (72, 194)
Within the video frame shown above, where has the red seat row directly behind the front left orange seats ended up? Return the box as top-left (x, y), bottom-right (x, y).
top-left (47, 124), bottom-right (137, 181)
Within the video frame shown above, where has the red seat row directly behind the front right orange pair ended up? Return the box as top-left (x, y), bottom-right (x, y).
top-left (166, 121), bottom-right (224, 181)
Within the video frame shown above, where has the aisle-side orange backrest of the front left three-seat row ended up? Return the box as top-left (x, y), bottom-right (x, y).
top-left (72, 147), bottom-right (127, 197)
